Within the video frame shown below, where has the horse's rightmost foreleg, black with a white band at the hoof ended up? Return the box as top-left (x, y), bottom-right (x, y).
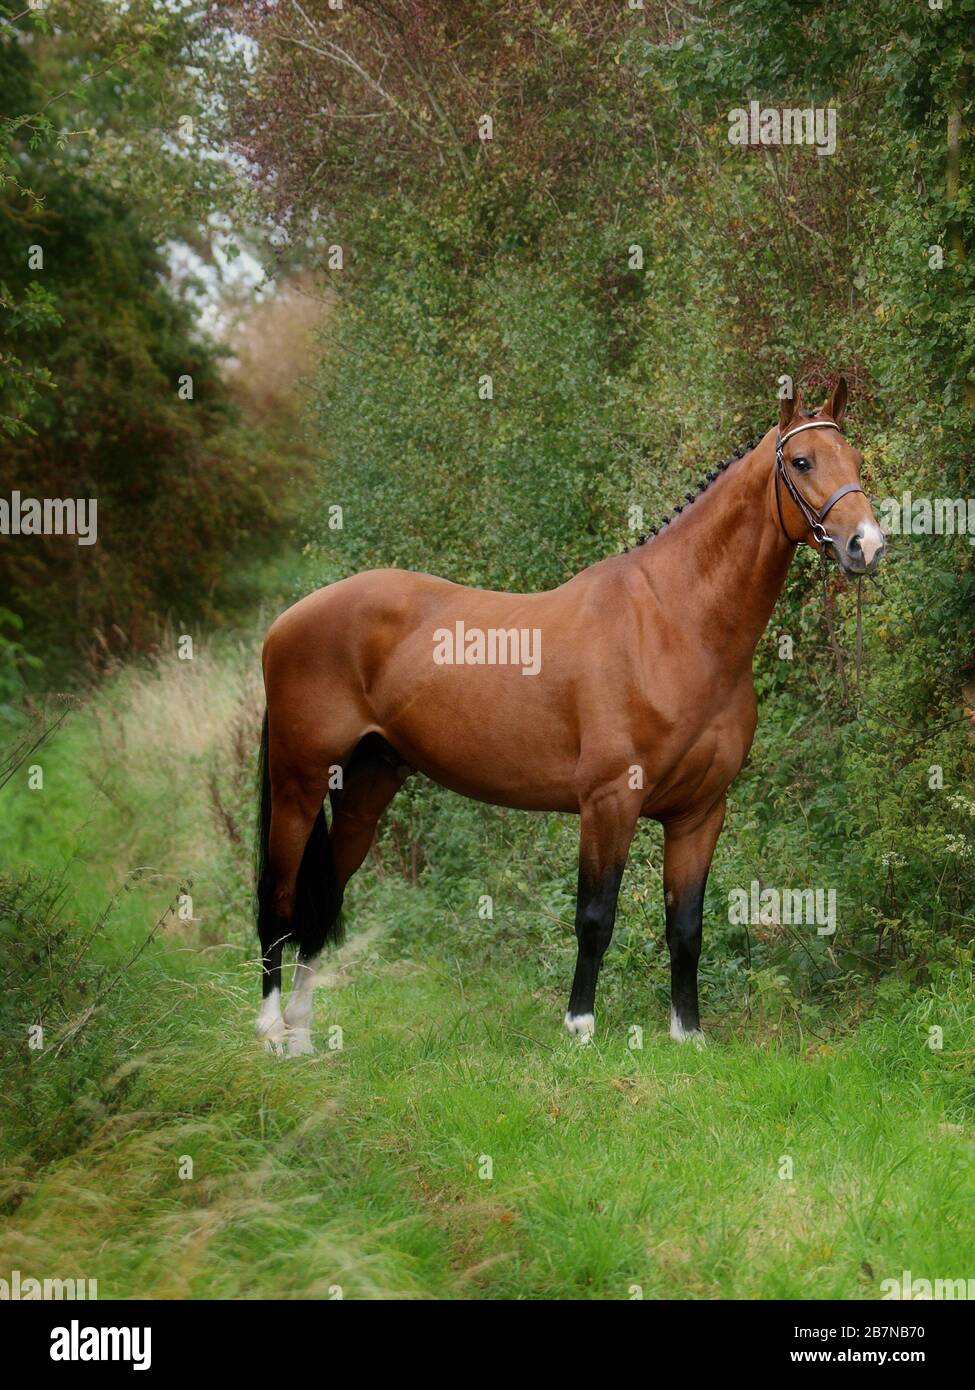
top-left (663, 796), bottom-right (725, 1043)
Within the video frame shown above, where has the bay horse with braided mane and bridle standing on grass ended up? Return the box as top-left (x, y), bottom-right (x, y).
top-left (257, 378), bottom-right (885, 1054)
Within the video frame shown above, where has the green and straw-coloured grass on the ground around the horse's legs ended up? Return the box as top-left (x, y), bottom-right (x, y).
top-left (0, 614), bottom-right (975, 1298)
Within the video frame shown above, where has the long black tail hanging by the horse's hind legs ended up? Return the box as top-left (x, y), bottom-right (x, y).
top-left (255, 710), bottom-right (344, 994)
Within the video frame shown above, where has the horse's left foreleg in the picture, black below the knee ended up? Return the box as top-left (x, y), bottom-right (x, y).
top-left (565, 791), bottom-right (640, 1044)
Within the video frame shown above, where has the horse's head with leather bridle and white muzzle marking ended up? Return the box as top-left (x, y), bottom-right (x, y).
top-left (773, 377), bottom-right (885, 575)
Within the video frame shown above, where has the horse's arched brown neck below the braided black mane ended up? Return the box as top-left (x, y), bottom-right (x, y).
top-left (631, 434), bottom-right (794, 669)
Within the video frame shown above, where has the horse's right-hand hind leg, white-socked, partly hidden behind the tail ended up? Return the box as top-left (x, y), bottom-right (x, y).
top-left (284, 739), bottom-right (408, 1056)
